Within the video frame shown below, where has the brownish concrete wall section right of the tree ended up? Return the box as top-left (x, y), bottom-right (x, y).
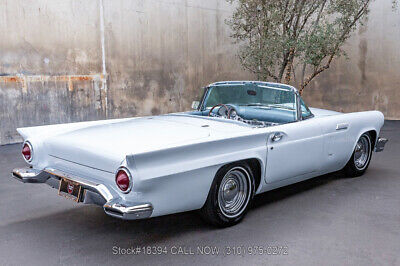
top-left (303, 0), bottom-right (400, 120)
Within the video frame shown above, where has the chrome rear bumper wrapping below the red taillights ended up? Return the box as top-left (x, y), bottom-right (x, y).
top-left (12, 168), bottom-right (153, 220)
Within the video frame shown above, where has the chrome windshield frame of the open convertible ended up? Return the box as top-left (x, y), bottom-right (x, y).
top-left (197, 81), bottom-right (314, 122)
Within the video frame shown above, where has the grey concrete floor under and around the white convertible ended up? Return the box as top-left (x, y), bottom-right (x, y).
top-left (0, 121), bottom-right (400, 265)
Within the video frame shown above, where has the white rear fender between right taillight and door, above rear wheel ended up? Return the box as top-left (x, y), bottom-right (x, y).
top-left (126, 133), bottom-right (267, 216)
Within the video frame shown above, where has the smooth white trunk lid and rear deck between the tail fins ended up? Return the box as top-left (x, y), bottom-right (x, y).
top-left (44, 116), bottom-right (217, 172)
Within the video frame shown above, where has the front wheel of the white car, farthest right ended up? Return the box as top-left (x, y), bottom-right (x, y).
top-left (344, 133), bottom-right (372, 177)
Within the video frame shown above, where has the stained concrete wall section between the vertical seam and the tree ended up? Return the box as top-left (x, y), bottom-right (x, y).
top-left (104, 0), bottom-right (249, 117)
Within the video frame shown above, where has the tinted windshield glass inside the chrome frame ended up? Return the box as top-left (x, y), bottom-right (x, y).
top-left (204, 83), bottom-right (296, 112)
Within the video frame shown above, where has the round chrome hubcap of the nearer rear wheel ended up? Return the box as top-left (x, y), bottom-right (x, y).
top-left (218, 167), bottom-right (251, 218)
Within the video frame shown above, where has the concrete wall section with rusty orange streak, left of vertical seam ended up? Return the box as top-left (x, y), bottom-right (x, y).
top-left (0, 0), bottom-right (104, 144)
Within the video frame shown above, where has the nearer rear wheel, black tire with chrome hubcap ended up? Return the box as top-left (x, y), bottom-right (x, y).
top-left (200, 162), bottom-right (254, 227)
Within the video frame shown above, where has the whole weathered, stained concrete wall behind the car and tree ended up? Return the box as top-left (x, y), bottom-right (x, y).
top-left (0, 0), bottom-right (400, 144)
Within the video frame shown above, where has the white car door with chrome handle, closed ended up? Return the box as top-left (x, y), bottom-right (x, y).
top-left (265, 118), bottom-right (324, 183)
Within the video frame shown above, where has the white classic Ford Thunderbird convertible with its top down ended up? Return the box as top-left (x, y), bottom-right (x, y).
top-left (12, 81), bottom-right (387, 226)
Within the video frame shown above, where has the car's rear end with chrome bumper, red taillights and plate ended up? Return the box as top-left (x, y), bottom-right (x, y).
top-left (12, 142), bottom-right (153, 220)
